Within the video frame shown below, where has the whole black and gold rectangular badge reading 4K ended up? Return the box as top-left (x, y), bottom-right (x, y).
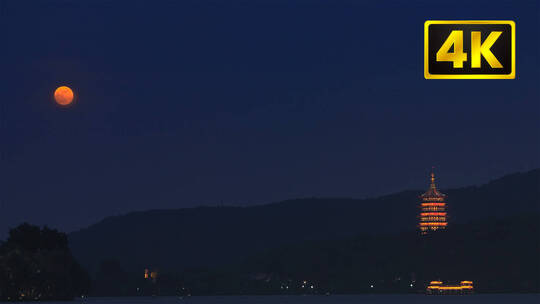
top-left (424, 20), bottom-right (516, 79)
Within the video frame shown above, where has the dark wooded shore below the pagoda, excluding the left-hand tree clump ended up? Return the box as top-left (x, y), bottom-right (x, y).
top-left (88, 214), bottom-right (540, 296)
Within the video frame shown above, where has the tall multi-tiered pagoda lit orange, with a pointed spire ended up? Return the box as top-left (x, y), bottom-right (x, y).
top-left (418, 171), bottom-right (448, 235)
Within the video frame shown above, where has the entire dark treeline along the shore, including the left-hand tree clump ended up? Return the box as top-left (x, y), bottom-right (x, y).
top-left (0, 213), bottom-right (540, 301)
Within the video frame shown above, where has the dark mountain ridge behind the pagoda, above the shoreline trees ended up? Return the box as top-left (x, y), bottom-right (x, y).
top-left (69, 169), bottom-right (540, 273)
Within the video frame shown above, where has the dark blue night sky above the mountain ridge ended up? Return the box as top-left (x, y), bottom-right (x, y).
top-left (0, 0), bottom-right (540, 235)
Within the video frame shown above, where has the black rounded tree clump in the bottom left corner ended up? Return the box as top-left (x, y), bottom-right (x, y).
top-left (0, 224), bottom-right (90, 301)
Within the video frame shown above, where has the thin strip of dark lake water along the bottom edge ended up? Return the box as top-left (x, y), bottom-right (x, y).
top-left (17, 294), bottom-right (540, 304)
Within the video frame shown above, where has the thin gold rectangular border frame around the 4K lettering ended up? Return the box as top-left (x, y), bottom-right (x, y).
top-left (424, 20), bottom-right (516, 79)
